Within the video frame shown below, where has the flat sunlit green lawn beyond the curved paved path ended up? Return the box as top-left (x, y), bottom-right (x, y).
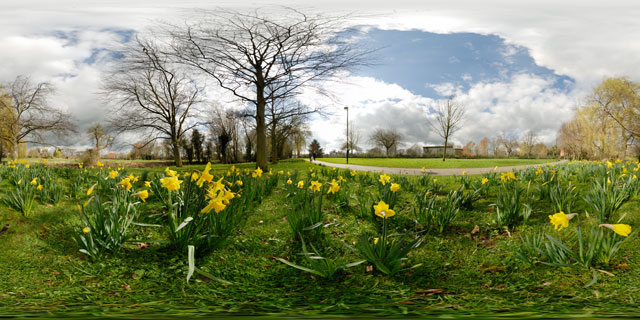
top-left (318, 158), bottom-right (556, 169)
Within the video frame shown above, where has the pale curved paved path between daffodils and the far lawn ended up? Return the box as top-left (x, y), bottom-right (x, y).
top-left (307, 160), bottom-right (567, 176)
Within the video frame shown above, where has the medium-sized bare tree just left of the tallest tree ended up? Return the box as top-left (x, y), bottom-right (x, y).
top-left (104, 38), bottom-right (201, 166)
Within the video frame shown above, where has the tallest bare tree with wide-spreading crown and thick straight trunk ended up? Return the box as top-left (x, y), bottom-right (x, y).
top-left (171, 9), bottom-right (367, 170)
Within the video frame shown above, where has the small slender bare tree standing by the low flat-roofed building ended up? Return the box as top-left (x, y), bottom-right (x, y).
top-left (429, 97), bottom-right (465, 161)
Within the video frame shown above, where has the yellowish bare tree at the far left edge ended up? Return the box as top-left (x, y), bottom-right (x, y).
top-left (0, 76), bottom-right (75, 159)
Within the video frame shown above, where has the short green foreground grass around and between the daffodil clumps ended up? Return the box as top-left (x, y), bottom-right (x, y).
top-left (0, 161), bottom-right (640, 318)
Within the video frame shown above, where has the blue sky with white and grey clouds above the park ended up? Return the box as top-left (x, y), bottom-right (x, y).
top-left (0, 0), bottom-right (640, 151)
